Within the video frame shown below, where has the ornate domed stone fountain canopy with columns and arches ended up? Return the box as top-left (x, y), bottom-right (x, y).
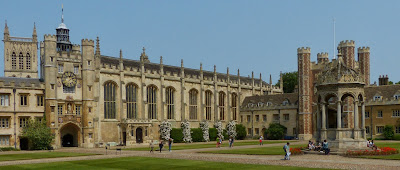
top-left (316, 53), bottom-right (366, 150)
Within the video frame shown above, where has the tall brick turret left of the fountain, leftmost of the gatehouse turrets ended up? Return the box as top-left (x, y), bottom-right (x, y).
top-left (297, 47), bottom-right (313, 140)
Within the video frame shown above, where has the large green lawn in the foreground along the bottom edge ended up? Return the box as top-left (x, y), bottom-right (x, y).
top-left (0, 157), bottom-right (326, 170)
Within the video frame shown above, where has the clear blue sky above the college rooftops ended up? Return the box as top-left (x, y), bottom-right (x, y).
top-left (0, 0), bottom-right (400, 83)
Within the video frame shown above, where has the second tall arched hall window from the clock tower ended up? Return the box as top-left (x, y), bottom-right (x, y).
top-left (126, 84), bottom-right (137, 119)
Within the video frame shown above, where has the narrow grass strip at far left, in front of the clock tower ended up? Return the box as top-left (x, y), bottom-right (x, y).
top-left (0, 152), bottom-right (95, 161)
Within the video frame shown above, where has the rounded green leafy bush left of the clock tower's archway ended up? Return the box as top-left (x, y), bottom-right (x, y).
top-left (22, 119), bottom-right (54, 150)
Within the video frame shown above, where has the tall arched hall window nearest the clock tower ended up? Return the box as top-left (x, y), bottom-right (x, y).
top-left (104, 82), bottom-right (116, 119)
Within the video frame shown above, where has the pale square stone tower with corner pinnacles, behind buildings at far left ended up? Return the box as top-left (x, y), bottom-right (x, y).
top-left (3, 23), bottom-right (38, 78)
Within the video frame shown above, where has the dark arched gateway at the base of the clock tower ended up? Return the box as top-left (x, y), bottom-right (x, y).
top-left (60, 123), bottom-right (81, 147)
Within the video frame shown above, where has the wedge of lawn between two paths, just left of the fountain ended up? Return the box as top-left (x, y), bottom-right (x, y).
top-left (200, 144), bottom-right (304, 155)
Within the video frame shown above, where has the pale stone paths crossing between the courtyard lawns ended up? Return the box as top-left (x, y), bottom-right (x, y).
top-left (0, 142), bottom-right (400, 169)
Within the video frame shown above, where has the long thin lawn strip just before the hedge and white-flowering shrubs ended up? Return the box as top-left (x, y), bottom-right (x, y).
top-left (125, 141), bottom-right (285, 151)
